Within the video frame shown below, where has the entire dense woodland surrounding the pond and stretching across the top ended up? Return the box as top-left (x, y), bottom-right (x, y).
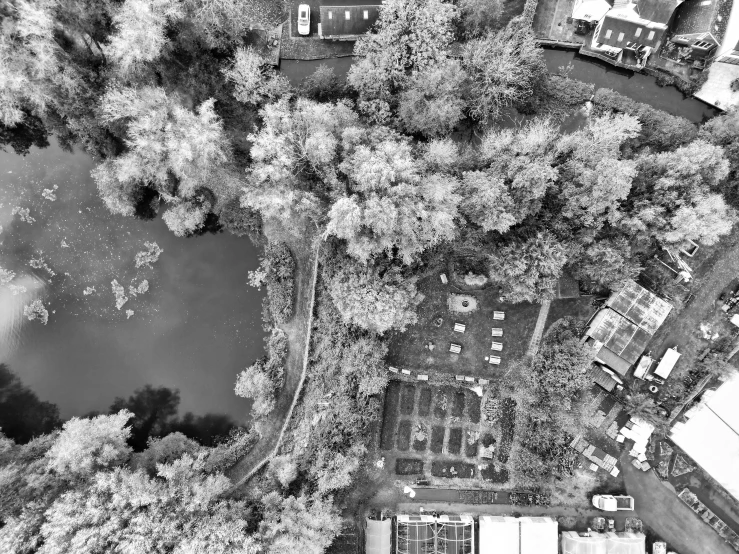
top-left (0, 0), bottom-right (739, 554)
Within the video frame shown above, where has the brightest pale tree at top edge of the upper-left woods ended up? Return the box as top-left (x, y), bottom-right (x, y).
top-left (105, 0), bottom-right (184, 74)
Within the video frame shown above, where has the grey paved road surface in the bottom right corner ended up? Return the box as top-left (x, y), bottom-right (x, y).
top-left (621, 453), bottom-right (736, 554)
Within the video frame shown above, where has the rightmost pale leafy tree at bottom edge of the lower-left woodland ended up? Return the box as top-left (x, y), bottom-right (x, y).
top-left (260, 492), bottom-right (341, 554)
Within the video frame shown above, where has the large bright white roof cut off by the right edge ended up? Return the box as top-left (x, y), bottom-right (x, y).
top-left (670, 373), bottom-right (739, 499)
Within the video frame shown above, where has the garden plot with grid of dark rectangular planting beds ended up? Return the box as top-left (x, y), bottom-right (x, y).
top-left (380, 380), bottom-right (515, 486)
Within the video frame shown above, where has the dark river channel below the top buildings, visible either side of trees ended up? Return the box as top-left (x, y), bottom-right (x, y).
top-left (280, 48), bottom-right (718, 123)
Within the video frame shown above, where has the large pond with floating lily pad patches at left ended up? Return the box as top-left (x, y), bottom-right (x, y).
top-left (0, 139), bottom-right (264, 423)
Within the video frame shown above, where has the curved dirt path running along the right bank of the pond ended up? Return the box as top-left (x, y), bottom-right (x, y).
top-left (227, 233), bottom-right (321, 489)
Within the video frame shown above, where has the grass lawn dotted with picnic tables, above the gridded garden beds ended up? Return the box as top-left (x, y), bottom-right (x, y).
top-left (387, 275), bottom-right (544, 378)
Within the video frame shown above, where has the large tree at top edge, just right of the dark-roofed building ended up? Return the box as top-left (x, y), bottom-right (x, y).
top-left (347, 0), bottom-right (458, 99)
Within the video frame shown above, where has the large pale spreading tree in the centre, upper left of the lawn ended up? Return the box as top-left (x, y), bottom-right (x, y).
top-left (326, 128), bottom-right (460, 263)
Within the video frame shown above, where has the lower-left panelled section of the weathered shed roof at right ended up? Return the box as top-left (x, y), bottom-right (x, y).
top-left (585, 308), bottom-right (652, 364)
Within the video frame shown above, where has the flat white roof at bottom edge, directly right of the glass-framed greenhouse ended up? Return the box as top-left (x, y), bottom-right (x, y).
top-left (480, 516), bottom-right (558, 554)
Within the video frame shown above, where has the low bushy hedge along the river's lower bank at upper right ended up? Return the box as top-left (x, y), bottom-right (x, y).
top-left (593, 88), bottom-right (698, 151)
